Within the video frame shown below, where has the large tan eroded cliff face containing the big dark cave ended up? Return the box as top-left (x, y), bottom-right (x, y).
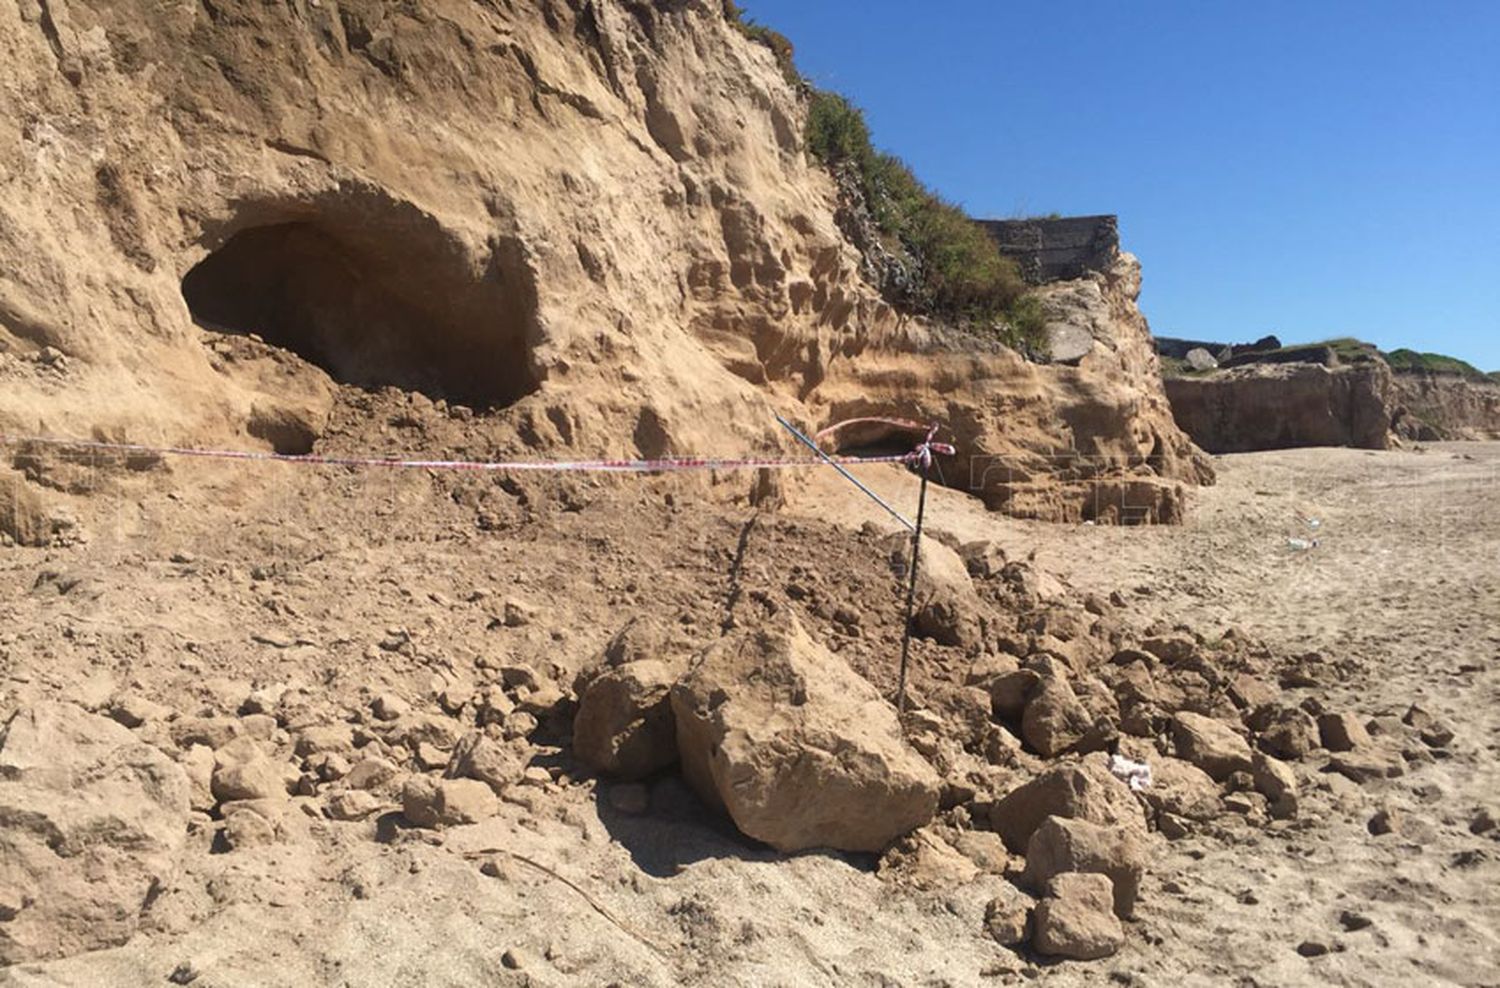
top-left (0, 0), bottom-right (1211, 520)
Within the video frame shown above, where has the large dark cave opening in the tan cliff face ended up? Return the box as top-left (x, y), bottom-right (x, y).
top-left (182, 208), bottom-right (537, 408)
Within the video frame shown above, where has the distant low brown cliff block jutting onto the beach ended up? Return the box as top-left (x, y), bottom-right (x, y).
top-left (1167, 360), bottom-right (1395, 453)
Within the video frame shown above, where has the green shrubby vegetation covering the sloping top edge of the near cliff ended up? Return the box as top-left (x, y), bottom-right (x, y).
top-left (807, 90), bottom-right (1046, 346)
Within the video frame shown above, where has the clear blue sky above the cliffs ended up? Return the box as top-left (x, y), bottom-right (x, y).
top-left (743, 0), bottom-right (1500, 370)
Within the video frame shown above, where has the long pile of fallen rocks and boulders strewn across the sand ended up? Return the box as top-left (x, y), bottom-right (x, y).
top-left (0, 540), bottom-right (1452, 961)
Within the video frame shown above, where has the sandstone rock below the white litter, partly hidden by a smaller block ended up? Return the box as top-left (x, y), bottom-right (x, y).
top-left (990, 756), bottom-right (1146, 855)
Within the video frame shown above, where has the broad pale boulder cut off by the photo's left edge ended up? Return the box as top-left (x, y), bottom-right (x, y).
top-left (0, 703), bottom-right (189, 964)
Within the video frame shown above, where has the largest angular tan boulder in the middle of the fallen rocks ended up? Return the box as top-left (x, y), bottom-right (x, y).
top-left (672, 622), bottom-right (942, 852)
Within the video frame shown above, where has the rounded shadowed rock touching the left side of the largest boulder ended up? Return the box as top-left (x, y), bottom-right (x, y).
top-left (573, 660), bottom-right (678, 780)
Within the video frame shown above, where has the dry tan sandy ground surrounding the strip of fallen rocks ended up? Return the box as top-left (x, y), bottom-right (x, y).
top-left (0, 428), bottom-right (1500, 987)
